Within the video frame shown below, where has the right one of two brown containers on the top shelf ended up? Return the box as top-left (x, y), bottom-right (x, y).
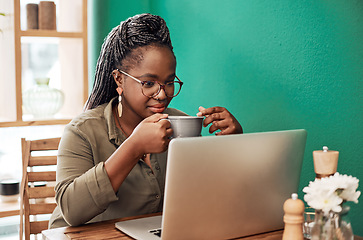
top-left (39, 1), bottom-right (57, 30)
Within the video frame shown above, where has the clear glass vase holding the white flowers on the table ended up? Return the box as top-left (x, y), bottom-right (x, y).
top-left (311, 207), bottom-right (354, 240)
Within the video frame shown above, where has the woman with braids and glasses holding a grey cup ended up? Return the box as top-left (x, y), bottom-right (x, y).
top-left (50, 14), bottom-right (242, 228)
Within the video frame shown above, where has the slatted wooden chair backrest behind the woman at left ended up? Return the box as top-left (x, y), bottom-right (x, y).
top-left (20, 138), bottom-right (60, 240)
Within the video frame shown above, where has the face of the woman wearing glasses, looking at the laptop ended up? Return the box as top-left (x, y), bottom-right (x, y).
top-left (122, 46), bottom-right (176, 122)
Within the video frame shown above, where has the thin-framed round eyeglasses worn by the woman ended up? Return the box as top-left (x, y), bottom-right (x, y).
top-left (117, 69), bottom-right (183, 98)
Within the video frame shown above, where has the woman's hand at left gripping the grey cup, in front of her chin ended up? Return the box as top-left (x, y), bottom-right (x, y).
top-left (129, 113), bottom-right (173, 154)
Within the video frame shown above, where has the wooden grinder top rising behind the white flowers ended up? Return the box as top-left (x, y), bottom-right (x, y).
top-left (313, 146), bottom-right (339, 178)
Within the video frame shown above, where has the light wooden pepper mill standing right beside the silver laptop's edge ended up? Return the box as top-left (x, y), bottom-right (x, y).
top-left (282, 193), bottom-right (305, 240)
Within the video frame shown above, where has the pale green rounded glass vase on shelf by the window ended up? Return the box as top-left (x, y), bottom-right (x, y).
top-left (23, 78), bottom-right (64, 119)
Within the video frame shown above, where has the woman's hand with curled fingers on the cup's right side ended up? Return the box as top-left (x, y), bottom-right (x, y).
top-left (197, 107), bottom-right (243, 135)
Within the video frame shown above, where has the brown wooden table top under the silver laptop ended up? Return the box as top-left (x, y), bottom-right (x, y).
top-left (42, 213), bottom-right (363, 240)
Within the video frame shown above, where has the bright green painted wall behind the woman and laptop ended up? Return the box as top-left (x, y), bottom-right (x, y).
top-left (90, 0), bottom-right (363, 236)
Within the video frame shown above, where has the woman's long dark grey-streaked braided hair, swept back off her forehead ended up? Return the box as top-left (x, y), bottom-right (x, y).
top-left (85, 13), bottom-right (174, 110)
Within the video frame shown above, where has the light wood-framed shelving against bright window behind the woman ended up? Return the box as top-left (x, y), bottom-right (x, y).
top-left (0, 0), bottom-right (88, 127)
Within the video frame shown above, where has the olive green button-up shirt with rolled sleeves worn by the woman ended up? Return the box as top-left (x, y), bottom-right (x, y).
top-left (49, 98), bottom-right (186, 228)
